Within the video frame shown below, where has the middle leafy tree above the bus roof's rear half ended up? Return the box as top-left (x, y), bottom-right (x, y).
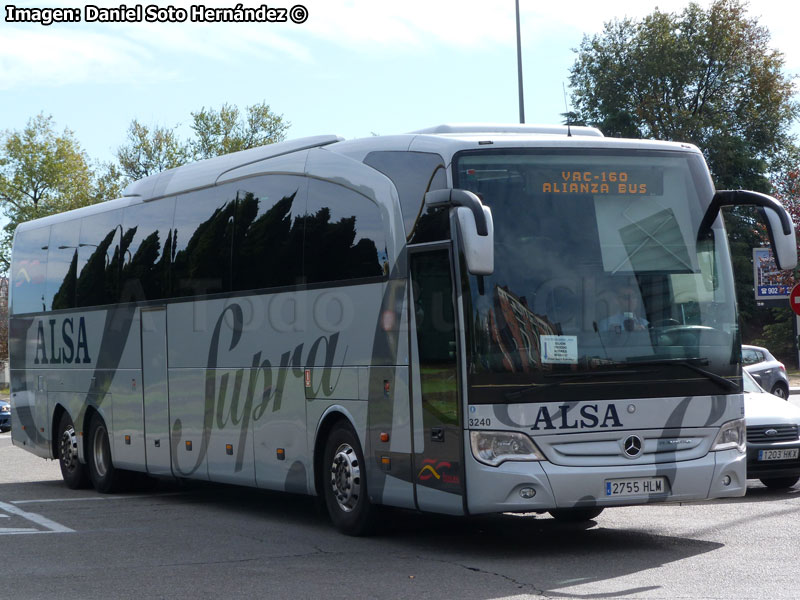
top-left (117, 119), bottom-right (191, 181)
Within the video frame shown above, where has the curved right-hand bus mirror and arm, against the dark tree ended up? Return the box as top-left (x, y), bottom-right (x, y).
top-left (697, 190), bottom-right (797, 270)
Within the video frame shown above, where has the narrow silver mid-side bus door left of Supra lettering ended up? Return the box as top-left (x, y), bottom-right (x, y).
top-left (141, 306), bottom-right (172, 475)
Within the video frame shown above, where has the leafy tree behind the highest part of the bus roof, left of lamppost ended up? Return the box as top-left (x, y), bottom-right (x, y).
top-left (190, 102), bottom-right (290, 159)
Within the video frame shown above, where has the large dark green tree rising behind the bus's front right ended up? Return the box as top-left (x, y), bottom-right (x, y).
top-left (570, 0), bottom-right (800, 191)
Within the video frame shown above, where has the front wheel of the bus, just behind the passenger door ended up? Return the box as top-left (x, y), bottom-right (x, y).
top-left (322, 423), bottom-right (375, 536)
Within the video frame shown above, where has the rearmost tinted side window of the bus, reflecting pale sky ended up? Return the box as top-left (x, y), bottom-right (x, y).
top-left (11, 227), bottom-right (50, 314)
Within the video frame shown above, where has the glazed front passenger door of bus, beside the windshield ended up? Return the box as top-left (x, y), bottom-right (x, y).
top-left (409, 244), bottom-right (465, 514)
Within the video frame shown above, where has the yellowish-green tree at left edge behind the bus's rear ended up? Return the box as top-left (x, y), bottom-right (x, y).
top-left (0, 114), bottom-right (98, 271)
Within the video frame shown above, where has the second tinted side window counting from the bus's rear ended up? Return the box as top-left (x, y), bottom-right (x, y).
top-left (44, 221), bottom-right (80, 310)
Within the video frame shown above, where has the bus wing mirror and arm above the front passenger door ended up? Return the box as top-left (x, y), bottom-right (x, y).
top-left (425, 189), bottom-right (494, 276)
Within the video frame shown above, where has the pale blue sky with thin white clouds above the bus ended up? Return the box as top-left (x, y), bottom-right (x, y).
top-left (0, 0), bottom-right (800, 166)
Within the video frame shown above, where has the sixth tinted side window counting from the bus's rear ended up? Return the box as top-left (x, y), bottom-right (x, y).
top-left (233, 175), bottom-right (306, 291)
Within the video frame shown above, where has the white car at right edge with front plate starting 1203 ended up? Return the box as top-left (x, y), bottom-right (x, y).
top-left (742, 371), bottom-right (800, 489)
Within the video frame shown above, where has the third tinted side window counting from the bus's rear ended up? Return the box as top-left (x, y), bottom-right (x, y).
top-left (76, 210), bottom-right (122, 306)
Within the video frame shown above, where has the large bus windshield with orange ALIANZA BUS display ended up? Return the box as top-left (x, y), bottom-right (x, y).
top-left (454, 149), bottom-right (741, 403)
